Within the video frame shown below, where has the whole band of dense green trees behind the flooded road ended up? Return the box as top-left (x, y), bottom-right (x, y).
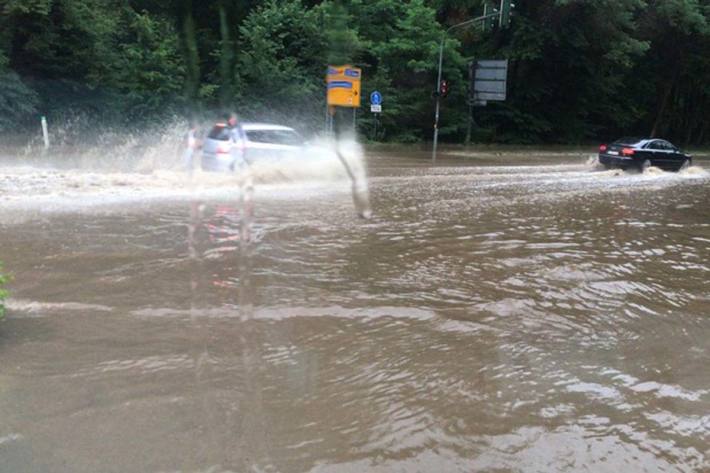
top-left (0, 0), bottom-right (710, 143)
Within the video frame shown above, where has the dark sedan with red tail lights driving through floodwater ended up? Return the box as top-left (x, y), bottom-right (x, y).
top-left (599, 138), bottom-right (693, 171)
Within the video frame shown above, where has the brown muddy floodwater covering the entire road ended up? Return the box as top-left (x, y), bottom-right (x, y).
top-left (0, 146), bottom-right (710, 473)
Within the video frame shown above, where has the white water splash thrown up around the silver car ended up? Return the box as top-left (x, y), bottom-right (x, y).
top-left (0, 120), bottom-right (371, 217)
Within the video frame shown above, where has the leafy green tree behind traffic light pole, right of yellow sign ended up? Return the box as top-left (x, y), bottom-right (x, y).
top-left (350, 0), bottom-right (466, 141)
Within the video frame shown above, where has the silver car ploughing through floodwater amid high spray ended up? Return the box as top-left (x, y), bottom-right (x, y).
top-left (202, 123), bottom-right (305, 171)
